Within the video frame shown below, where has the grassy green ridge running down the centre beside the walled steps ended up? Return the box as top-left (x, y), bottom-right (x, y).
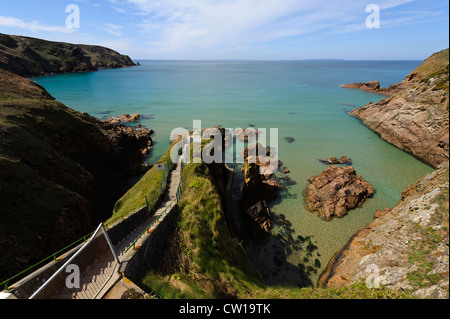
top-left (142, 163), bottom-right (263, 298)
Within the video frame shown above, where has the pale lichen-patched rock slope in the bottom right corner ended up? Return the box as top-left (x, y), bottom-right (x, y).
top-left (318, 162), bottom-right (449, 298)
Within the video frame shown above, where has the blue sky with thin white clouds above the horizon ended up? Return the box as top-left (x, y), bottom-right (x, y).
top-left (0, 0), bottom-right (449, 60)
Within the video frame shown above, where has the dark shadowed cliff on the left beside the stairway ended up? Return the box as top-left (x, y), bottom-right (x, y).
top-left (0, 69), bottom-right (152, 281)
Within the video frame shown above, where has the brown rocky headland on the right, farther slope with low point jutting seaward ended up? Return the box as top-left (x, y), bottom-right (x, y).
top-left (350, 49), bottom-right (449, 168)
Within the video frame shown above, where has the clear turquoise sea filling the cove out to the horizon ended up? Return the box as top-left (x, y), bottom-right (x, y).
top-left (33, 60), bottom-right (432, 285)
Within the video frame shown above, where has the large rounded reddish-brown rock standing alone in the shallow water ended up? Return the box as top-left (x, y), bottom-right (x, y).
top-left (305, 166), bottom-right (375, 220)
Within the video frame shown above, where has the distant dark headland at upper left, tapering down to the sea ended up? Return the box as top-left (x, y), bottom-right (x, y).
top-left (0, 33), bottom-right (135, 77)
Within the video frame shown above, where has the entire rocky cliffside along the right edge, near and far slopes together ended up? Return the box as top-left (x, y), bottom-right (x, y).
top-left (318, 49), bottom-right (449, 298)
